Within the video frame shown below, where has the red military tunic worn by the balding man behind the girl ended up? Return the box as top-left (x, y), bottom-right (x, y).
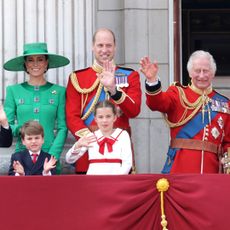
top-left (66, 67), bottom-right (141, 172)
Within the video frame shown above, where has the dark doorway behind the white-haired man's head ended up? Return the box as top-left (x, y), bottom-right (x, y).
top-left (182, 0), bottom-right (230, 84)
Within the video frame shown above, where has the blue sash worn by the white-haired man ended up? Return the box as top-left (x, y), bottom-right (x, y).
top-left (161, 94), bottom-right (226, 173)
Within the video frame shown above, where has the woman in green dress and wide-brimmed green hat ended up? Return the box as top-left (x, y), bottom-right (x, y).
top-left (3, 43), bottom-right (69, 170)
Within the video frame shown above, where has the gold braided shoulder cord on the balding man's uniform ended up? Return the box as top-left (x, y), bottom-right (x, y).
top-left (70, 73), bottom-right (103, 121)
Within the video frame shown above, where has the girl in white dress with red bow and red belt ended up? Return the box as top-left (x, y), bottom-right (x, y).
top-left (66, 100), bottom-right (132, 175)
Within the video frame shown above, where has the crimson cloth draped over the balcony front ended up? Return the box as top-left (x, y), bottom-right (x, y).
top-left (0, 174), bottom-right (230, 230)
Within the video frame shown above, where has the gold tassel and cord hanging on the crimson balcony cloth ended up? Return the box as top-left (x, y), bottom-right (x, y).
top-left (156, 178), bottom-right (169, 230)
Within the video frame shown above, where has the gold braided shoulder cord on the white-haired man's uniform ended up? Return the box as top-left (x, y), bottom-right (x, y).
top-left (163, 86), bottom-right (203, 128)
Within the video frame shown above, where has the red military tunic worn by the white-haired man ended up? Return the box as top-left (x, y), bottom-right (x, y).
top-left (146, 83), bottom-right (230, 173)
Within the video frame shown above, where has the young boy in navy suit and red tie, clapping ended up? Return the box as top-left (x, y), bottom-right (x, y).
top-left (9, 121), bottom-right (57, 176)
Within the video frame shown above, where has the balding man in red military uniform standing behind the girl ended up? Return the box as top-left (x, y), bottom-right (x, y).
top-left (66, 29), bottom-right (141, 173)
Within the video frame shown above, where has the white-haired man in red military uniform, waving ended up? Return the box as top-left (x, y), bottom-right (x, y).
top-left (140, 50), bottom-right (230, 173)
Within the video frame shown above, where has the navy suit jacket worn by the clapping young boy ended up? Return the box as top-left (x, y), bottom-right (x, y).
top-left (8, 149), bottom-right (56, 176)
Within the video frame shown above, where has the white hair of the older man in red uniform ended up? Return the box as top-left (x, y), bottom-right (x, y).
top-left (187, 50), bottom-right (216, 75)
